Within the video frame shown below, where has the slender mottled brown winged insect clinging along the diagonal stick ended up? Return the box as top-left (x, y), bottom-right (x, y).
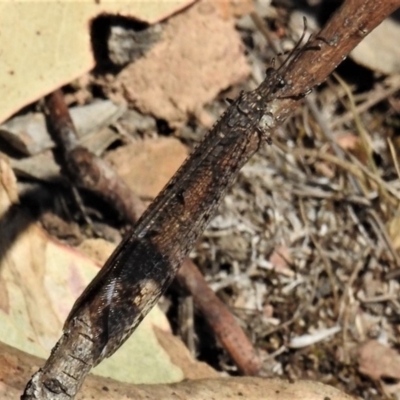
top-left (21, 13), bottom-right (322, 397)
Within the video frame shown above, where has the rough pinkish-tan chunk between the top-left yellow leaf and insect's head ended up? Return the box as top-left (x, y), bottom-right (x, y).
top-left (109, 0), bottom-right (250, 127)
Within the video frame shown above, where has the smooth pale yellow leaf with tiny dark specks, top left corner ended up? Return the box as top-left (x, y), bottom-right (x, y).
top-left (0, 0), bottom-right (193, 122)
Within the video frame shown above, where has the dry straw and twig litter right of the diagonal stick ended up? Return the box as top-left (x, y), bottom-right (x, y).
top-left (186, 4), bottom-right (400, 399)
